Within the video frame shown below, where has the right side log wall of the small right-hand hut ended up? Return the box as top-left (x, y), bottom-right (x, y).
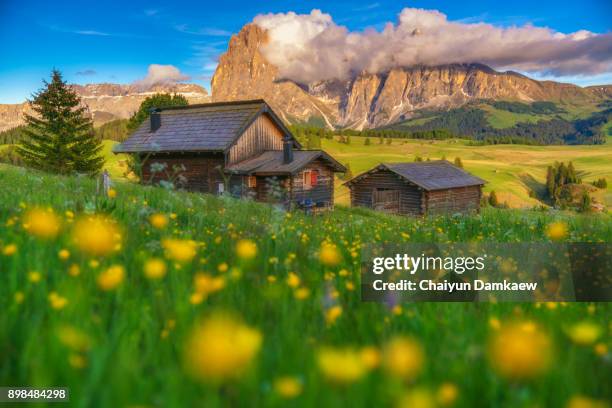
top-left (426, 186), bottom-right (482, 214)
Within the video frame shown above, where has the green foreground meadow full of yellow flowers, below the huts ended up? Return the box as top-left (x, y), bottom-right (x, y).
top-left (0, 166), bottom-right (612, 408)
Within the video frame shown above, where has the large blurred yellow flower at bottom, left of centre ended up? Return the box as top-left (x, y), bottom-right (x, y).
top-left (184, 315), bottom-right (262, 381)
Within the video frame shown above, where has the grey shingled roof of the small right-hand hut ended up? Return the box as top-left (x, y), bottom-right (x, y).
top-left (344, 160), bottom-right (486, 191)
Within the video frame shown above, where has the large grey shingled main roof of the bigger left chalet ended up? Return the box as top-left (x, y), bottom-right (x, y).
top-left (113, 99), bottom-right (299, 153)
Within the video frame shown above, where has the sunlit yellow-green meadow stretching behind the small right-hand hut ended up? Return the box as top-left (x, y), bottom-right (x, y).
top-left (322, 137), bottom-right (612, 207)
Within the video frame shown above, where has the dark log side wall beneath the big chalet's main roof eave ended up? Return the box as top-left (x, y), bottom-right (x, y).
top-left (142, 153), bottom-right (225, 194)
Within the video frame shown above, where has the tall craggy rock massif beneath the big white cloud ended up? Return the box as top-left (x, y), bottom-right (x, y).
top-left (211, 24), bottom-right (612, 129)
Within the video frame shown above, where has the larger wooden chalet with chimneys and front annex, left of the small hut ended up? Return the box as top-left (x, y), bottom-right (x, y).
top-left (114, 100), bottom-right (346, 208)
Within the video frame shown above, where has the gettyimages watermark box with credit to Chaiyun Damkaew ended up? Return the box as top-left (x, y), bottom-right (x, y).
top-left (361, 243), bottom-right (612, 303)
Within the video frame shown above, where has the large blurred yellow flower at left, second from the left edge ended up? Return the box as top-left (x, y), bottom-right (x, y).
top-left (72, 215), bottom-right (121, 256)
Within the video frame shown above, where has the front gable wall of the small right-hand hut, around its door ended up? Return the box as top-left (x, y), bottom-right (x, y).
top-left (350, 169), bottom-right (424, 215)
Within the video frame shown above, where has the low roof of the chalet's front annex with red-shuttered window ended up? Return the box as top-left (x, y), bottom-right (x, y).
top-left (225, 150), bottom-right (346, 175)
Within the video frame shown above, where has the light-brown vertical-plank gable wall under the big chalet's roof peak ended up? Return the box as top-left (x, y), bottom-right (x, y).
top-left (227, 114), bottom-right (283, 165)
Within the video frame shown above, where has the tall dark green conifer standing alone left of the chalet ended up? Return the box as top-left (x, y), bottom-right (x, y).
top-left (17, 69), bottom-right (104, 175)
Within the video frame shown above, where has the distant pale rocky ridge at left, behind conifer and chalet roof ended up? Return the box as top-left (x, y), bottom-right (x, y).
top-left (0, 83), bottom-right (210, 131)
